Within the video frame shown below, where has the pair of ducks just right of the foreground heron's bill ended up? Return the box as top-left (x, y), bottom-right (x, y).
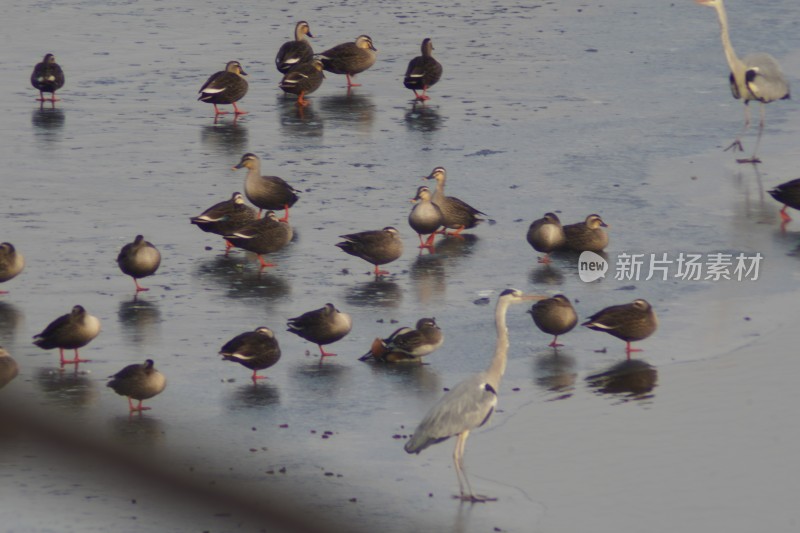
top-left (528, 294), bottom-right (658, 357)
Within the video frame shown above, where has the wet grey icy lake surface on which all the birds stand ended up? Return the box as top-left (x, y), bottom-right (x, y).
top-left (0, 0), bottom-right (800, 532)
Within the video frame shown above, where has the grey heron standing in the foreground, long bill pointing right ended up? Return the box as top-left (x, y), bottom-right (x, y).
top-left (404, 289), bottom-right (545, 502)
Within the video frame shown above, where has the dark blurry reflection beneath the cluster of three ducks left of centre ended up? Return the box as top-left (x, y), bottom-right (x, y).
top-left (197, 256), bottom-right (291, 301)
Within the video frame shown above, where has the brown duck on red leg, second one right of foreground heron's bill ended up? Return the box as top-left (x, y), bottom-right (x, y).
top-left (581, 298), bottom-right (658, 358)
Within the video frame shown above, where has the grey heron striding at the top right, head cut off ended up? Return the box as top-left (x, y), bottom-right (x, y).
top-left (695, 0), bottom-right (790, 164)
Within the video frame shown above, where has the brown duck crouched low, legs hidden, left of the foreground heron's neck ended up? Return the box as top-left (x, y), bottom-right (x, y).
top-left (358, 318), bottom-right (444, 363)
